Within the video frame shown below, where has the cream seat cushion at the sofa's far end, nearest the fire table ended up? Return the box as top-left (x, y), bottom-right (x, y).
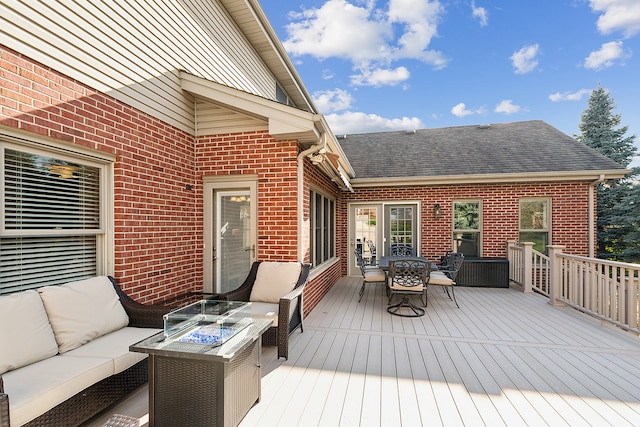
top-left (65, 326), bottom-right (162, 374)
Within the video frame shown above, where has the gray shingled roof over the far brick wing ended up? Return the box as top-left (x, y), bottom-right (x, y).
top-left (339, 120), bottom-right (624, 179)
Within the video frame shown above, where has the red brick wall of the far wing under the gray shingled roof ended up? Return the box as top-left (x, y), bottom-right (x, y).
top-left (339, 182), bottom-right (589, 274)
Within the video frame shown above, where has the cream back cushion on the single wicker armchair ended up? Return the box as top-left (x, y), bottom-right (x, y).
top-left (249, 261), bottom-right (302, 303)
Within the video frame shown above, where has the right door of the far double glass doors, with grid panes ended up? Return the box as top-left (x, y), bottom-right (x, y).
top-left (384, 204), bottom-right (420, 254)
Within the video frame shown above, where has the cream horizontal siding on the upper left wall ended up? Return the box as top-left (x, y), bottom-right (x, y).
top-left (0, 0), bottom-right (276, 134)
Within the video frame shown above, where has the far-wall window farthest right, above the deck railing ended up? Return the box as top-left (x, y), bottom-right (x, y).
top-left (519, 199), bottom-right (551, 254)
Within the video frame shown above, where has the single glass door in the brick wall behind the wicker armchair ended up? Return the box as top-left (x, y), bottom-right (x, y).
top-left (203, 177), bottom-right (257, 292)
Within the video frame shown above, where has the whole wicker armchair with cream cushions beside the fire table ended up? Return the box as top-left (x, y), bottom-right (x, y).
top-left (213, 261), bottom-right (310, 359)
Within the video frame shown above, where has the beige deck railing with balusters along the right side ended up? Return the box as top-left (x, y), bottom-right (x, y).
top-left (507, 242), bottom-right (640, 334)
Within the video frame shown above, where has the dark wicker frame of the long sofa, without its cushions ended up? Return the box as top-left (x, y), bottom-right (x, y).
top-left (0, 277), bottom-right (170, 427)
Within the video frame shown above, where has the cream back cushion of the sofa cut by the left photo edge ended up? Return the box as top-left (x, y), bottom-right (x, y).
top-left (0, 290), bottom-right (58, 374)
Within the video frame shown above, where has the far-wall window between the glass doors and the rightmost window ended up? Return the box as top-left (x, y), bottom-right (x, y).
top-left (453, 201), bottom-right (481, 258)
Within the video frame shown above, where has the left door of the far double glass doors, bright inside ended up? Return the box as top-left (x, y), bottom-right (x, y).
top-left (349, 205), bottom-right (382, 275)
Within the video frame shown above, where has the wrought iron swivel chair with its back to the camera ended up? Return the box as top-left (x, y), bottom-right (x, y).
top-left (387, 257), bottom-right (431, 317)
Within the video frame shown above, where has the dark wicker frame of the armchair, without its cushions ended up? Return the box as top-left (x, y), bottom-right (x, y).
top-left (213, 261), bottom-right (311, 359)
